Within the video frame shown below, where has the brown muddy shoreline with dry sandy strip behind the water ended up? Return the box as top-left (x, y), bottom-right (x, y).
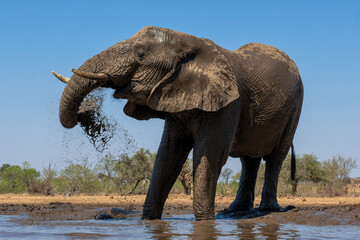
top-left (0, 194), bottom-right (360, 226)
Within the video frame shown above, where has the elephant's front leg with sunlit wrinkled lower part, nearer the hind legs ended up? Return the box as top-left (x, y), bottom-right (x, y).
top-left (193, 108), bottom-right (237, 220)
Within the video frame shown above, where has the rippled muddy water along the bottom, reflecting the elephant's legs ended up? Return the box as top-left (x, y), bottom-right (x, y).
top-left (0, 215), bottom-right (360, 239)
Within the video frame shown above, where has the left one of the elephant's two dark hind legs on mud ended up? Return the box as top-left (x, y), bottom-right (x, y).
top-left (224, 157), bottom-right (261, 213)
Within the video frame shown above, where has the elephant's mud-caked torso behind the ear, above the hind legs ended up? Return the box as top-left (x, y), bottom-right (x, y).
top-left (231, 43), bottom-right (303, 157)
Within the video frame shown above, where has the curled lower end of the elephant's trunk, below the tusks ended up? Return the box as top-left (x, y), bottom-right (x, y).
top-left (59, 75), bottom-right (100, 128)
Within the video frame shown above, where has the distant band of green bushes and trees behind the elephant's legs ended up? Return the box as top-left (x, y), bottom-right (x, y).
top-left (0, 149), bottom-right (360, 197)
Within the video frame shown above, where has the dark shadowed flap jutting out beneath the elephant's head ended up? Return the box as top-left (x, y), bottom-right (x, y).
top-left (124, 101), bottom-right (165, 120)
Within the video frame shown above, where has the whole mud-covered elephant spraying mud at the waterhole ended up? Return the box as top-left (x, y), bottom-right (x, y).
top-left (53, 26), bottom-right (303, 220)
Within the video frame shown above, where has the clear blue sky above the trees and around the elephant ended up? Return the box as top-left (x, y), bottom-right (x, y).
top-left (0, 0), bottom-right (360, 176)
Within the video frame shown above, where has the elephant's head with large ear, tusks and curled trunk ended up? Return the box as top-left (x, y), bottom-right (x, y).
top-left (54, 27), bottom-right (239, 128)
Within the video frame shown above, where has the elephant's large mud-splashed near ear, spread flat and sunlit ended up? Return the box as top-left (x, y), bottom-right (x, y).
top-left (147, 38), bottom-right (239, 112)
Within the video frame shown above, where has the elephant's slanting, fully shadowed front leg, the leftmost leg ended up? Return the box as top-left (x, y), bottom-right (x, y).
top-left (142, 119), bottom-right (193, 219)
